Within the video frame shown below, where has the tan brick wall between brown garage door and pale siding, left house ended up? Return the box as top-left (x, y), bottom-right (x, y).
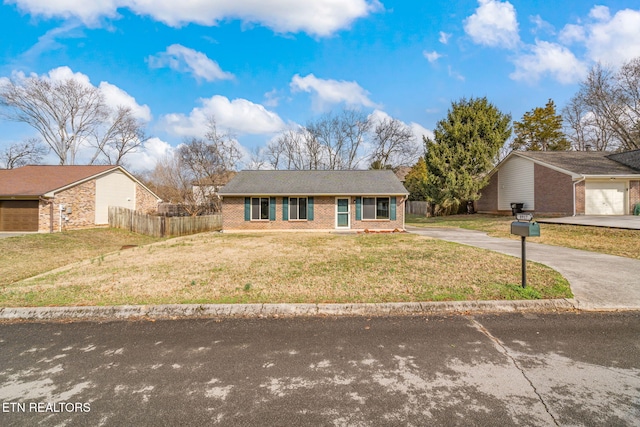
top-left (39, 180), bottom-right (96, 232)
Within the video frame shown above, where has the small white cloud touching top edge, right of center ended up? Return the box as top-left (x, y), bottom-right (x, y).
top-left (464, 0), bottom-right (520, 48)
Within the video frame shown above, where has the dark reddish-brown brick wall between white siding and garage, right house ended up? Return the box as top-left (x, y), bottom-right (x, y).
top-left (533, 163), bottom-right (573, 215)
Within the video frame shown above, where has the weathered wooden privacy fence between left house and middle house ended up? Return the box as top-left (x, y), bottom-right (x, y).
top-left (109, 206), bottom-right (222, 237)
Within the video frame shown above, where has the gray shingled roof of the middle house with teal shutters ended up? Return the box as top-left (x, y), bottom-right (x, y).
top-left (219, 170), bottom-right (409, 196)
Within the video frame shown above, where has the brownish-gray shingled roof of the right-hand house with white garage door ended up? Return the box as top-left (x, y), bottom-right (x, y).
top-left (518, 151), bottom-right (640, 175)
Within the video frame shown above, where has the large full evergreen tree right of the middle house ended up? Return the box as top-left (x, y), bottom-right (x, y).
top-left (424, 98), bottom-right (511, 214)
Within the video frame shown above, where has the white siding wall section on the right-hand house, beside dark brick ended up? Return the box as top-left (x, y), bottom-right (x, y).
top-left (498, 156), bottom-right (535, 210)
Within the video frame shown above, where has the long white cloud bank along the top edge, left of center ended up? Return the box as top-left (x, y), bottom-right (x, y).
top-left (5, 0), bottom-right (382, 36)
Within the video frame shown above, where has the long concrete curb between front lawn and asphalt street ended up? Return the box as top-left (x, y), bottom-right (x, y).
top-left (0, 299), bottom-right (596, 321)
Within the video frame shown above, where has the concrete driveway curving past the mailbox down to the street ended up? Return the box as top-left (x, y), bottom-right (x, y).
top-left (406, 226), bottom-right (640, 310)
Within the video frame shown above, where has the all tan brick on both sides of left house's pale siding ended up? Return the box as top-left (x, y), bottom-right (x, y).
top-left (38, 179), bottom-right (157, 233)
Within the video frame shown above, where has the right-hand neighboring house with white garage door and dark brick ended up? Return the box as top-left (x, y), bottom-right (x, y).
top-left (476, 150), bottom-right (640, 215)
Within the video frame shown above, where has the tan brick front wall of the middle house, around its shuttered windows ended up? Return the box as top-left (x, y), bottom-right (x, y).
top-left (222, 196), bottom-right (404, 230)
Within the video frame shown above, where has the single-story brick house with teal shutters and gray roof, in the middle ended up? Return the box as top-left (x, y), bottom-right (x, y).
top-left (219, 170), bottom-right (409, 231)
